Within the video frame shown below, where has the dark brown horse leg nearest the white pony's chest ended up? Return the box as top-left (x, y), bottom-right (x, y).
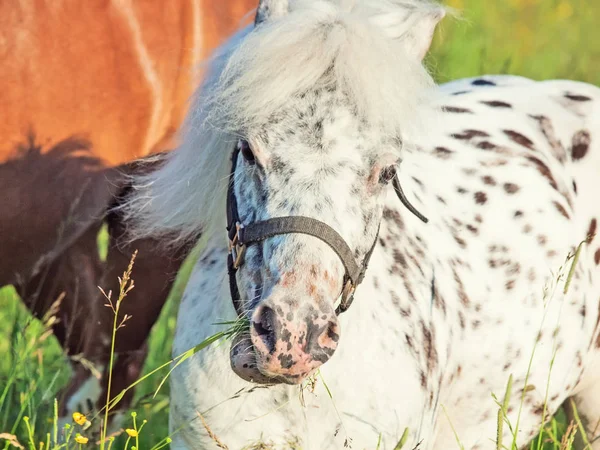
top-left (65, 215), bottom-right (184, 425)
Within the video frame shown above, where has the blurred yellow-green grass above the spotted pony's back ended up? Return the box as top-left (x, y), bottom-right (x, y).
top-left (429, 0), bottom-right (600, 85)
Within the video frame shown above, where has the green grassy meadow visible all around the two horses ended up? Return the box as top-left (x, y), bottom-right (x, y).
top-left (0, 0), bottom-right (600, 450)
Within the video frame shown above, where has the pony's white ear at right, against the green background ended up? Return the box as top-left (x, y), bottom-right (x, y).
top-left (373, 5), bottom-right (446, 61)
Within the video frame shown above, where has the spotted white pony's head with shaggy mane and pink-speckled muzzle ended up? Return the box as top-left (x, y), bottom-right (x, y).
top-left (128, 0), bottom-right (444, 383)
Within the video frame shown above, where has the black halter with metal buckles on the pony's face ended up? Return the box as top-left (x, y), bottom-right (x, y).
top-left (227, 146), bottom-right (427, 316)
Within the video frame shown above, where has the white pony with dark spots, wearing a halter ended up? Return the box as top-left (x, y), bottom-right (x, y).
top-left (128, 0), bottom-right (600, 450)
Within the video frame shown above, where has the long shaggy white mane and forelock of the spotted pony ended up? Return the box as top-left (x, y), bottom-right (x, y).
top-left (122, 0), bottom-right (440, 243)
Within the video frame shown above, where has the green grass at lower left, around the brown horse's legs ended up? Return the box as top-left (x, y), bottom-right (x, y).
top-left (0, 232), bottom-right (191, 449)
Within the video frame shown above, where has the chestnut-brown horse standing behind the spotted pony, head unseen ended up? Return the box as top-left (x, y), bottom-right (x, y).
top-left (0, 0), bottom-right (256, 428)
